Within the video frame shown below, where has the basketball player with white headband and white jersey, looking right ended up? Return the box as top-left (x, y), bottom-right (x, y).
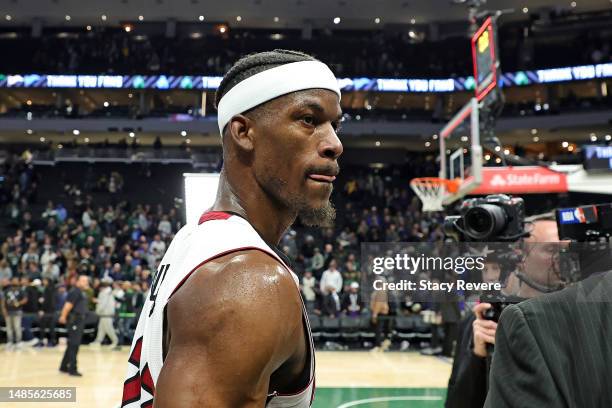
top-left (122, 50), bottom-right (342, 408)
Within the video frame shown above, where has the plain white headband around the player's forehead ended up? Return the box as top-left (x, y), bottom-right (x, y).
top-left (217, 61), bottom-right (340, 136)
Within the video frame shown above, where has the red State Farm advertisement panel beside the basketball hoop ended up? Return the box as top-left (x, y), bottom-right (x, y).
top-left (470, 166), bottom-right (568, 195)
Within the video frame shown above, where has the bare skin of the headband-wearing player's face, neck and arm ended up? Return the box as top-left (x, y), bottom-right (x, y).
top-left (154, 89), bottom-right (342, 408)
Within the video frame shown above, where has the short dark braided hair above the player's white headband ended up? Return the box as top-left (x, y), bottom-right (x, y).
top-left (215, 49), bottom-right (317, 108)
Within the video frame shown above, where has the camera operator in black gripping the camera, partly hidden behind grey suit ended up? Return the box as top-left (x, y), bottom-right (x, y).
top-left (445, 214), bottom-right (559, 408)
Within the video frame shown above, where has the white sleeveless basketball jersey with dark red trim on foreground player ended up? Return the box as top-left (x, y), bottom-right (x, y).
top-left (121, 212), bottom-right (315, 408)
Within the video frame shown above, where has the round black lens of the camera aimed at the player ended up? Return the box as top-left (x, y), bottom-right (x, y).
top-left (464, 204), bottom-right (508, 241)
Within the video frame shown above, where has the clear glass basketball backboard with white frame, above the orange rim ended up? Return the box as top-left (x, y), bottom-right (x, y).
top-left (439, 98), bottom-right (482, 204)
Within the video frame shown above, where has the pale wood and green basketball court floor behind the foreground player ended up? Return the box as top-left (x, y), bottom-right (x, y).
top-left (0, 346), bottom-right (451, 408)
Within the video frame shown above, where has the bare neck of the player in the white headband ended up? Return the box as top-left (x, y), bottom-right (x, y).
top-left (212, 168), bottom-right (297, 245)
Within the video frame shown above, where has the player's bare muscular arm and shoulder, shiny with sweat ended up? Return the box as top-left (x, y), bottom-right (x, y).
top-left (154, 251), bottom-right (303, 408)
